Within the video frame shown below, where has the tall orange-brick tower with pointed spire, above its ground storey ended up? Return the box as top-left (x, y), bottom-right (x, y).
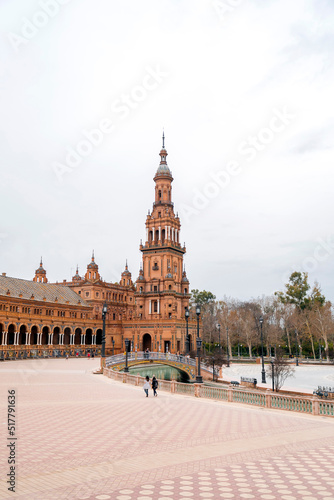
top-left (136, 134), bottom-right (190, 340)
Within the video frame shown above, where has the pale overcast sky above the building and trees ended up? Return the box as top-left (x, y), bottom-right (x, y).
top-left (0, 0), bottom-right (334, 301)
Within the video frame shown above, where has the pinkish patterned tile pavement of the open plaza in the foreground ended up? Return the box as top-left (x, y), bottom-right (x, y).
top-left (0, 359), bottom-right (334, 500)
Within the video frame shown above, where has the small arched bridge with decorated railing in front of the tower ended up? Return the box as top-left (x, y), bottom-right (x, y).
top-left (105, 351), bottom-right (212, 380)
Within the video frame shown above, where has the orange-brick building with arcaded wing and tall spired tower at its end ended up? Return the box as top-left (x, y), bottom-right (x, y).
top-left (0, 136), bottom-right (196, 358)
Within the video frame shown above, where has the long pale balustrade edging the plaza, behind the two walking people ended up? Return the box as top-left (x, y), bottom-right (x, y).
top-left (103, 368), bottom-right (334, 417)
